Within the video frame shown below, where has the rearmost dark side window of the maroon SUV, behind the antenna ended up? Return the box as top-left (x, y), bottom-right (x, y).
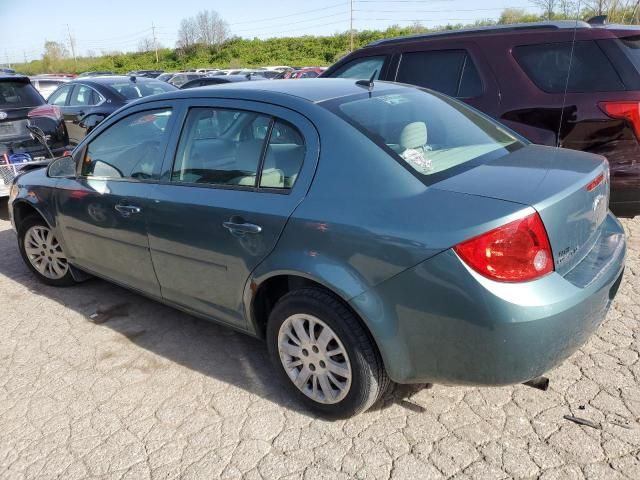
top-left (513, 40), bottom-right (625, 93)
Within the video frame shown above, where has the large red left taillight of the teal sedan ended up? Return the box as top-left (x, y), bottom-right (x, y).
top-left (454, 213), bottom-right (554, 282)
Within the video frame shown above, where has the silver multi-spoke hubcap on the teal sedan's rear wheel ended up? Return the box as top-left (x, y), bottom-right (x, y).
top-left (278, 314), bottom-right (351, 404)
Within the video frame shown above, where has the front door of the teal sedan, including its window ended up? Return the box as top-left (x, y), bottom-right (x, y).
top-left (56, 102), bottom-right (173, 297)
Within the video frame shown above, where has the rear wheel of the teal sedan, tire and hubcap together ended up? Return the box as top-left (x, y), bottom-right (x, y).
top-left (267, 288), bottom-right (389, 419)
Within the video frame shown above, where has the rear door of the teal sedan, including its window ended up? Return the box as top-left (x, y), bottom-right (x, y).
top-left (147, 99), bottom-right (319, 328)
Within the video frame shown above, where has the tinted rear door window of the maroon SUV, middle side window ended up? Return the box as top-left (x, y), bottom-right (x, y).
top-left (396, 50), bottom-right (482, 98)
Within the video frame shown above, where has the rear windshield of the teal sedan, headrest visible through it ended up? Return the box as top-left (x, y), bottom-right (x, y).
top-left (321, 89), bottom-right (524, 177)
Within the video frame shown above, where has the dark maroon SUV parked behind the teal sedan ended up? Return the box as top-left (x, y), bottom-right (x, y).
top-left (322, 21), bottom-right (640, 216)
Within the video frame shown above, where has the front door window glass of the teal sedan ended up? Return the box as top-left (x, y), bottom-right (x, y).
top-left (82, 108), bottom-right (171, 180)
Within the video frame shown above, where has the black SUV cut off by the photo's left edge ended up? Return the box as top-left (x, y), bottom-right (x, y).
top-left (0, 73), bottom-right (69, 197)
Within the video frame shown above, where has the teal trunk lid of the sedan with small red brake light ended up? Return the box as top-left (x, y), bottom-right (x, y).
top-left (433, 145), bottom-right (609, 275)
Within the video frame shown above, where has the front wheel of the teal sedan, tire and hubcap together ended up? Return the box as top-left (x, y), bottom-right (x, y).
top-left (18, 215), bottom-right (76, 287)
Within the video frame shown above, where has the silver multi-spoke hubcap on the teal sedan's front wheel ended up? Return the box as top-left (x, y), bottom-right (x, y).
top-left (24, 225), bottom-right (69, 280)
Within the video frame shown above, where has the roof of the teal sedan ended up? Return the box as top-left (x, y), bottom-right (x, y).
top-left (145, 78), bottom-right (415, 103)
